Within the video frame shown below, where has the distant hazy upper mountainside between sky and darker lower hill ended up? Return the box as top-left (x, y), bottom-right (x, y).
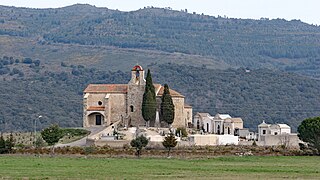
top-left (0, 4), bottom-right (320, 78)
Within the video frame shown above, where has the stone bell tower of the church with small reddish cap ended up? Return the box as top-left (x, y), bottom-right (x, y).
top-left (127, 65), bottom-right (146, 127)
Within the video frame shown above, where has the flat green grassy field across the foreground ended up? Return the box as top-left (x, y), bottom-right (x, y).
top-left (0, 156), bottom-right (320, 179)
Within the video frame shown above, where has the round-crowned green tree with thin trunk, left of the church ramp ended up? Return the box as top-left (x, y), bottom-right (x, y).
top-left (41, 124), bottom-right (63, 153)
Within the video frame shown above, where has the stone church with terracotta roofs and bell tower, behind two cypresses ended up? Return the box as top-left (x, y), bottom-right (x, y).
top-left (83, 65), bottom-right (192, 128)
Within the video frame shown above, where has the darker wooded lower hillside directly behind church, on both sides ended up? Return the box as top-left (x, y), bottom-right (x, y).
top-left (0, 58), bottom-right (320, 131)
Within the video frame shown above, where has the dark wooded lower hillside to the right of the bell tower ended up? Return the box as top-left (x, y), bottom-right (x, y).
top-left (150, 64), bottom-right (320, 131)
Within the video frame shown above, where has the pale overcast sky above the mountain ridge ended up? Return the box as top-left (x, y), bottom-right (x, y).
top-left (0, 0), bottom-right (320, 25)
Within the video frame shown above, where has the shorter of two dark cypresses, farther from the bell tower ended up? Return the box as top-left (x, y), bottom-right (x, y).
top-left (160, 84), bottom-right (174, 125)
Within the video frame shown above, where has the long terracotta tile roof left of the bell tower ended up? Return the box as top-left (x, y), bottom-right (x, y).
top-left (84, 84), bottom-right (128, 93)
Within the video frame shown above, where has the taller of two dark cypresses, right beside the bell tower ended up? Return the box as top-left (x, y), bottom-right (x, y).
top-left (141, 69), bottom-right (157, 125)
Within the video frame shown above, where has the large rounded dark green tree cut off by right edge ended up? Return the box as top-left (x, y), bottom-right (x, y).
top-left (298, 117), bottom-right (320, 154)
